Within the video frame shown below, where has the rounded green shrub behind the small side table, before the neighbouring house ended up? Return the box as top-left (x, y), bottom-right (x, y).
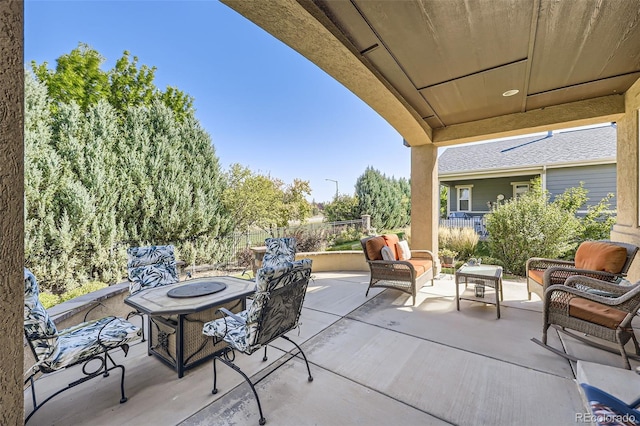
top-left (486, 190), bottom-right (579, 275)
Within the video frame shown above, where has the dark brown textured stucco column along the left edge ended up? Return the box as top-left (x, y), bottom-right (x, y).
top-left (0, 0), bottom-right (24, 425)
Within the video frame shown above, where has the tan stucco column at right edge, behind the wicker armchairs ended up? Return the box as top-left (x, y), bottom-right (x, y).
top-left (611, 80), bottom-right (640, 282)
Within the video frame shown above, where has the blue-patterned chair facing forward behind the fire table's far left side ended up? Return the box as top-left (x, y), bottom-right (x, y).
top-left (127, 245), bottom-right (179, 342)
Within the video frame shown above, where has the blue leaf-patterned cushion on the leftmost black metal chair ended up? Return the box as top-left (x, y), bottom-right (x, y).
top-left (24, 268), bottom-right (141, 372)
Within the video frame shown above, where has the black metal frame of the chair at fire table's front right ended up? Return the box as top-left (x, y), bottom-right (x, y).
top-left (211, 271), bottom-right (313, 425)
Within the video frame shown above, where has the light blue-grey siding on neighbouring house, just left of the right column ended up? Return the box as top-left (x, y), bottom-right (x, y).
top-left (544, 164), bottom-right (616, 210)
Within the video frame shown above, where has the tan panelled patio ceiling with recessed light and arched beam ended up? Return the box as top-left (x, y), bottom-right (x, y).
top-left (223, 0), bottom-right (640, 146)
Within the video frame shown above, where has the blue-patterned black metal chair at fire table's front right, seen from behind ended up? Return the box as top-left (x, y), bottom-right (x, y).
top-left (202, 259), bottom-right (313, 425)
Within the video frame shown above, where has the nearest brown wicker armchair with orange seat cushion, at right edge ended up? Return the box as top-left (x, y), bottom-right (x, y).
top-left (532, 275), bottom-right (640, 370)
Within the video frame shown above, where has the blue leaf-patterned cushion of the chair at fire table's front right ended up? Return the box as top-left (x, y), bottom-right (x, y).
top-left (202, 259), bottom-right (312, 354)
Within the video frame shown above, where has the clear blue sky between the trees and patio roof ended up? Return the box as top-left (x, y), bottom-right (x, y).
top-left (25, 0), bottom-right (411, 201)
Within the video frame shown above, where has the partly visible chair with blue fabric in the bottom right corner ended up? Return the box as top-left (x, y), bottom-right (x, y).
top-left (576, 383), bottom-right (640, 426)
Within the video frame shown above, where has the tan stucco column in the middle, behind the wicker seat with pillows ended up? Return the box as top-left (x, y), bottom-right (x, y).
top-left (411, 144), bottom-right (440, 255)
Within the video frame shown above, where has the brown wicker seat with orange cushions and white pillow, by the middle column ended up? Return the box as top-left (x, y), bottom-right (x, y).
top-left (360, 235), bottom-right (434, 306)
